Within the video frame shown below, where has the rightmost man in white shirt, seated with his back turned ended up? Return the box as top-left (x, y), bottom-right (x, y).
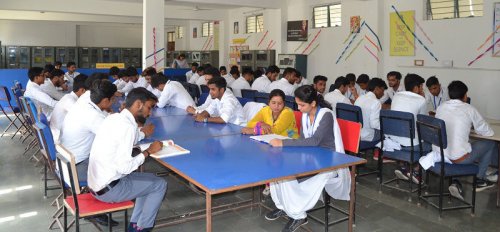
top-left (438, 81), bottom-right (498, 196)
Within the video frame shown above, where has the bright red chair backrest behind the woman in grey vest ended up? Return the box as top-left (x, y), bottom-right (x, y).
top-left (337, 118), bottom-right (361, 154)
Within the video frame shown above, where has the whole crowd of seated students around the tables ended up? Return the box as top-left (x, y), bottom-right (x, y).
top-left (25, 60), bottom-right (498, 231)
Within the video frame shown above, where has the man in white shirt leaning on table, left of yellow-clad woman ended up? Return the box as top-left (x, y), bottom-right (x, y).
top-left (188, 76), bottom-right (247, 126)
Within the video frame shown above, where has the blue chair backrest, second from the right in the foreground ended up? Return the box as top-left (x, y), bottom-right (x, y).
top-left (380, 110), bottom-right (415, 139)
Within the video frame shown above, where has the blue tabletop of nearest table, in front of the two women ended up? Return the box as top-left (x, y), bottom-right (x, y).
top-left (159, 135), bottom-right (365, 194)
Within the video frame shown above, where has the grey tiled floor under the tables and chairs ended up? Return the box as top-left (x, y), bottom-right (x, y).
top-left (0, 117), bottom-right (500, 232)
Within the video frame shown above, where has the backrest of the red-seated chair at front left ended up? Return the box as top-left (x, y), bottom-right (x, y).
top-left (56, 144), bottom-right (80, 195)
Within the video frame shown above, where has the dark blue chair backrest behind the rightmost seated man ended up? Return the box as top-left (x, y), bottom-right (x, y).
top-left (417, 114), bottom-right (448, 150)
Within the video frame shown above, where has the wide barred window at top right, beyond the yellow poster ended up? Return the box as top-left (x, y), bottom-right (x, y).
top-left (427, 0), bottom-right (483, 20)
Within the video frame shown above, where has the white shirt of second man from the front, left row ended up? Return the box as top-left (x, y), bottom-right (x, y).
top-left (60, 102), bottom-right (107, 163)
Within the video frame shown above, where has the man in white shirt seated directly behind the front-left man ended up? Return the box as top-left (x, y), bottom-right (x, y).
top-left (60, 80), bottom-right (116, 181)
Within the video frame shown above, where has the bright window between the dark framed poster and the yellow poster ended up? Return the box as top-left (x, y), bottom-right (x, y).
top-left (313, 4), bottom-right (342, 28)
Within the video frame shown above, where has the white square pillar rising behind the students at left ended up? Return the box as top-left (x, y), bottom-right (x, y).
top-left (142, 0), bottom-right (167, 71)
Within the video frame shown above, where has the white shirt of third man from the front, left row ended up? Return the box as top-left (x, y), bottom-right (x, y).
top-left (50, 91), bottom-right (78, 142)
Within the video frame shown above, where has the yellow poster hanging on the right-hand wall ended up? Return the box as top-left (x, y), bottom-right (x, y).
top-left (389, 11), bottom-right (415, 56)
